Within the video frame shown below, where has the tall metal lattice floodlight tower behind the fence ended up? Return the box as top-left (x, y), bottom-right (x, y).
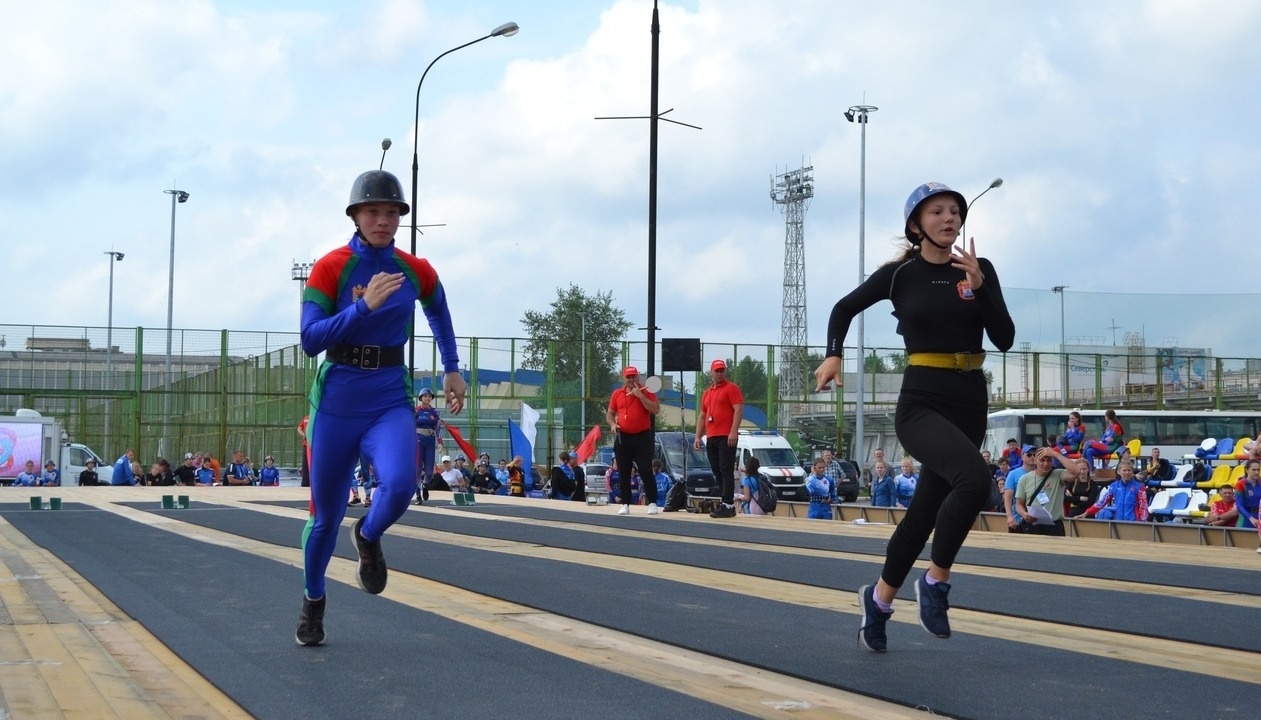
top-left (770, 165), bottom-right (815, 424)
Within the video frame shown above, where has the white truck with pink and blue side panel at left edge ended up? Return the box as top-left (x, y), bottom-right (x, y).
top-left (0, 409), bottom-right (113, 487)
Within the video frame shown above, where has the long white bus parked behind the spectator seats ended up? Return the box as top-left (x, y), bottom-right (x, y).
top-left (981, 407), bottom-right (1261, 464)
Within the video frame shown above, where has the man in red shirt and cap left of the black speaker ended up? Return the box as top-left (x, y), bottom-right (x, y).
top-left (604, 366), bottom-right (661, 514)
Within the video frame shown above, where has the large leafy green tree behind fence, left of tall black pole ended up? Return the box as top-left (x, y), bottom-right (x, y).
top-left (521, 282), bottom-right (631, 431)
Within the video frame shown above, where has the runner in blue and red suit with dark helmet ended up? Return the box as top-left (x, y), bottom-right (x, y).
top-left (294, 170), bottom-right (465, 646)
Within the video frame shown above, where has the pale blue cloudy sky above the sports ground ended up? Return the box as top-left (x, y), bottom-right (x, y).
top-left (0, 0), bottom-right (1261, 357)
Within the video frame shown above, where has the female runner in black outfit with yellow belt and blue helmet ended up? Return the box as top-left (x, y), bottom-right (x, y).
top-left (815, 183), bottom-right (1015, 652)
